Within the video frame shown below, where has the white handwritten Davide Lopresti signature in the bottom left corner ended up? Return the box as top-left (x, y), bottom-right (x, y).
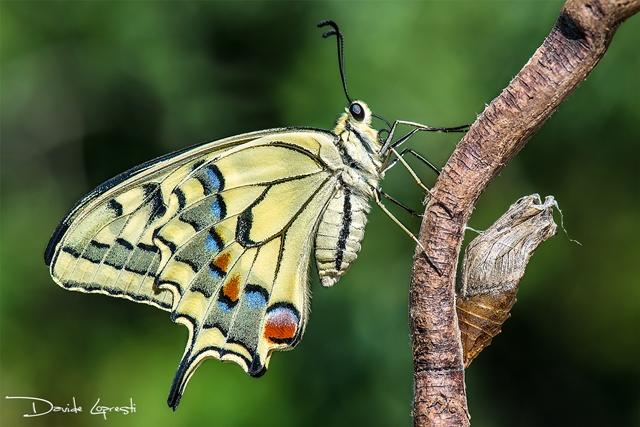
top-left (5, 396), bottom-right (136, 420)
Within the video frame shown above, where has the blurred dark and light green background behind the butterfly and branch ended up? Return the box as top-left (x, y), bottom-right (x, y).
top-left (0, 1), bottom-right (640, 427)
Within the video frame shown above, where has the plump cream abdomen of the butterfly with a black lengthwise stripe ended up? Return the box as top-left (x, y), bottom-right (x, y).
top-left (315, 186), bottom-right (370, 286)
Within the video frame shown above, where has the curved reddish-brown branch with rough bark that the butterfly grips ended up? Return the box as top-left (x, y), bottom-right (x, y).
top-left (409, 0), bottom-right (640, 426)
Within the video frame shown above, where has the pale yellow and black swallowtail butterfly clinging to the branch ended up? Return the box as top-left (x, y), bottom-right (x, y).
top-left (45, 21), bottom-right (464, 410)
